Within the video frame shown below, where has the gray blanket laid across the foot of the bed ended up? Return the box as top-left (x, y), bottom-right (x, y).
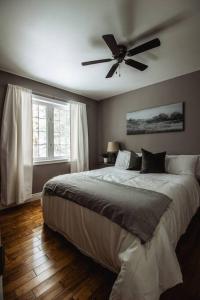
top-left (43, 173), bottom-right (171, 242)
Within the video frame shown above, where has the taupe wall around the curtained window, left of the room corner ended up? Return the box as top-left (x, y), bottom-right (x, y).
top-left (0, 71), bottom-right (98, 193)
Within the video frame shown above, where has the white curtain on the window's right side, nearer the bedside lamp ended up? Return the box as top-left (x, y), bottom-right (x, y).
top-left (70, 102), bottom-right (89, 173)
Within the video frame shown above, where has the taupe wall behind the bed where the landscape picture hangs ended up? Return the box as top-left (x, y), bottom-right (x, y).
top-left (98, 71), bottom-right (200, 154)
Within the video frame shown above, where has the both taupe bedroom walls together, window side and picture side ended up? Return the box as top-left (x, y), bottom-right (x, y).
top-left (0, 71), bottom-right (200, 193)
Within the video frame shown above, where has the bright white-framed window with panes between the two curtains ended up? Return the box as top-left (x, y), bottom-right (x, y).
top-left (33, 96), bottom-right (70, 162)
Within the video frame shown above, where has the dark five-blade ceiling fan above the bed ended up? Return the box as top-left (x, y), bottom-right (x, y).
top-left (82, 34), bottom-right (161, 78)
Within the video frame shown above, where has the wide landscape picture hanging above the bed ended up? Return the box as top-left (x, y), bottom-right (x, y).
top-left (126, 102), bottom-right (184, 135)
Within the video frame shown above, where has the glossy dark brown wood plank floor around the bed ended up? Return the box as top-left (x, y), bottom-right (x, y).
top-left (0, 201), bottom-right (200, 300)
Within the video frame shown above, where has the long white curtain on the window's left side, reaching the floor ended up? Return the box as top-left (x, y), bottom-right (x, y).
top-left (1, 84), bottom-right (33, 206)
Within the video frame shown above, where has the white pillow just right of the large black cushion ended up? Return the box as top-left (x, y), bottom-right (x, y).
top-left (165, 155), bottom-right (198, 176)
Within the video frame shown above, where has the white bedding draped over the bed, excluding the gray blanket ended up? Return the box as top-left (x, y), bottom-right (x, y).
top-left (43, 167), bottom-right (200, 300)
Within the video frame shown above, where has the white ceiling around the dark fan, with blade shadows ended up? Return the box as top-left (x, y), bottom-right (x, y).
top-left (0, 0), bottom-right (200, 100)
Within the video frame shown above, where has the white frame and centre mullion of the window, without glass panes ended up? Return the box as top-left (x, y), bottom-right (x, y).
top-left (32, 94), bottom-right (71, 165)
